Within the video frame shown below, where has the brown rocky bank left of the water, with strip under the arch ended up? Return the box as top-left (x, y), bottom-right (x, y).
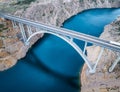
top-left (0, 19), bottom-right (42, 71)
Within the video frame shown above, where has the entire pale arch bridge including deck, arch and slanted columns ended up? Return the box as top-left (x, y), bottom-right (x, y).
top-left (0, 12), bottom-right (120, 73)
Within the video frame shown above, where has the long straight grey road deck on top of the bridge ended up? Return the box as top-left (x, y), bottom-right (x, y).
top-left (0, 13), bottom-right (120, 52)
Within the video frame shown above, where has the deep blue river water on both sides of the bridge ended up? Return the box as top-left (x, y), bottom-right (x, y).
top-left (0, 9), bottom-right (120, 92)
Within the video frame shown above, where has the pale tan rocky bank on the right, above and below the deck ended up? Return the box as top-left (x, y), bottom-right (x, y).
top-left (81, 18), bottom-right (120, 92)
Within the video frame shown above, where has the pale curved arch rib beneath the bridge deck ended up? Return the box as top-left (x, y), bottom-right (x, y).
top-left (26, 31), bottom-right (95, 73)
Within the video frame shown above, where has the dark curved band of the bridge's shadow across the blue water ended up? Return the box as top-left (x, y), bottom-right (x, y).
top-left (26, 51), bottom-right (80, 89)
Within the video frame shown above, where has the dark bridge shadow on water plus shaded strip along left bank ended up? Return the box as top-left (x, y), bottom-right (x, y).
top-left (24, 34), bottom-right (80, 90)
